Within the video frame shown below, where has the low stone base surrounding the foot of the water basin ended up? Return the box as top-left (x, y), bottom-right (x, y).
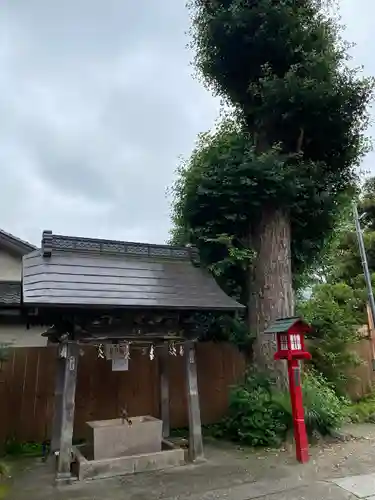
top-left (74, 440), bottom-right (185, 480)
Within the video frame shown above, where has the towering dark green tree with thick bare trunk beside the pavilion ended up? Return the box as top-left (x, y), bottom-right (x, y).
top-left (174, 0), bottom-right (372, 372)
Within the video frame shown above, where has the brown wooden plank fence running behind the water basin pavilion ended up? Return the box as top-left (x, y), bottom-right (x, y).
top-left (0, 343), bottom-right (245, 443)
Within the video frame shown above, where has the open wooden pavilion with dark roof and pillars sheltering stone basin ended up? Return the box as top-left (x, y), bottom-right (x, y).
top-left (22, 231), bottom-right (247, 477)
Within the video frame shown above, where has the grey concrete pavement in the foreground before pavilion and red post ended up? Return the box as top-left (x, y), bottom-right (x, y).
top-left (6, 424), bottom-right (375, 500)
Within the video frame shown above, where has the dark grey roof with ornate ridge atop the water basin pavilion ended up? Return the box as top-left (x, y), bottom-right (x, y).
top-left (23, 232), bottom-right (243, 311)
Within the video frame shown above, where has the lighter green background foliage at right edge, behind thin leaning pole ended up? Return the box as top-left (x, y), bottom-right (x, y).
top-left (300, 178), bottom-right (375, 393)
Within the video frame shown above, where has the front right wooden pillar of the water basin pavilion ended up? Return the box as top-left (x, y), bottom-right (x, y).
top-left (185, 341), bottom-right (203, 461)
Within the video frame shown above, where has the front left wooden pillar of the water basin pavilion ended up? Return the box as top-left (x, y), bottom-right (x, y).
top-left (57, 343), bottom-right (79, 479)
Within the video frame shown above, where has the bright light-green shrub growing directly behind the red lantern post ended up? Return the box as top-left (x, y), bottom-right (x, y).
top-left (273, 371), bottom-right (348, 436)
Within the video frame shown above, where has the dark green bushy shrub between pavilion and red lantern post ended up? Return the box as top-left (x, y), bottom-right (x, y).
top-left (215, 373), bottom-right (286, 446)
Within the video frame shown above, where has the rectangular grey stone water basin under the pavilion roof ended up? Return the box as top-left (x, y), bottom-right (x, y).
top-left (87, 415), bottom-right (163, 460)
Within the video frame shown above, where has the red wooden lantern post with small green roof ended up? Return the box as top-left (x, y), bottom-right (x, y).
top-left (264, 317), bottom-right (311, 463)
